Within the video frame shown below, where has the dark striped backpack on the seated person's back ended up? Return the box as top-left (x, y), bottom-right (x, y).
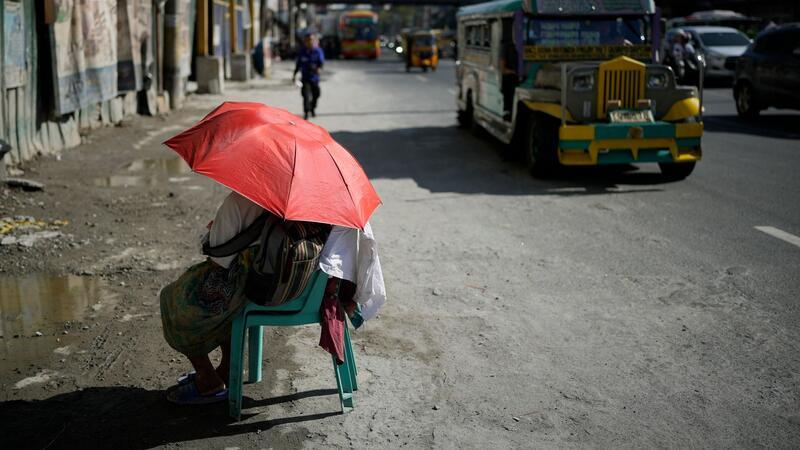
top-left (203, 213), bottom-right (331, 306)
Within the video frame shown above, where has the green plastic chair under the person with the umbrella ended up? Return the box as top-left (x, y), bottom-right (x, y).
top-left (228, 270), bottom-right (358, 420)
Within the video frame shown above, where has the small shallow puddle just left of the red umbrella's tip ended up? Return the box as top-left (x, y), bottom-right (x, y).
top-left (94, 157), bottom-right (192, 187)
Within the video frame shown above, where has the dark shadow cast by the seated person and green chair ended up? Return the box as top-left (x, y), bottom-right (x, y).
top-left (0, 387), bottom-right (341, 449)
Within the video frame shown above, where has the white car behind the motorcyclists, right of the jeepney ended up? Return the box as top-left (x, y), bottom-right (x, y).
top-left (662, 26), bottom-right (750, 78)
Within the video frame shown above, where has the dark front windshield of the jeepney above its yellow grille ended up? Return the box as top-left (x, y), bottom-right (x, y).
top-left (525, 17), bottom-right (648, 47)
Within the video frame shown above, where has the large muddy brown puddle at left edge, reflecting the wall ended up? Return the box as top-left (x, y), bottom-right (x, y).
top-left (0, 274), bottom-right (117, 368)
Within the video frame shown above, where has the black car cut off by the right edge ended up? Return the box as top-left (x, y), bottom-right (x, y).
top-left (729, 23), bottom-right (800, 117)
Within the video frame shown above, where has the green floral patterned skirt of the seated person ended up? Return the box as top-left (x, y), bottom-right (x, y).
top-left (161, 248), bottom-right (253, 357)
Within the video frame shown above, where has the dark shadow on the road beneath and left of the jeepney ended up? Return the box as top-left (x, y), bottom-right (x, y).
top-left (332, 126), bottom-right (680, 196)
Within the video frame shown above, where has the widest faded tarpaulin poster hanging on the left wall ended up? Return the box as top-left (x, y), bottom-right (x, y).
top-left (51, 0), bottom-right (118, 114)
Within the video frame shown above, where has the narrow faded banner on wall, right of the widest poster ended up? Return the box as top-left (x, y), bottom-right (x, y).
top-left (117, 0), bottom-right (153, 92)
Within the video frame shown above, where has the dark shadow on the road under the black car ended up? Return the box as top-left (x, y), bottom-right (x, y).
top-left (703, 113), bottom-right (800, 139)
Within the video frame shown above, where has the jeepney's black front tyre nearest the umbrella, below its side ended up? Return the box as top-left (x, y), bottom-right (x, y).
top-left (522, 114), bottom-right (558, 178)
